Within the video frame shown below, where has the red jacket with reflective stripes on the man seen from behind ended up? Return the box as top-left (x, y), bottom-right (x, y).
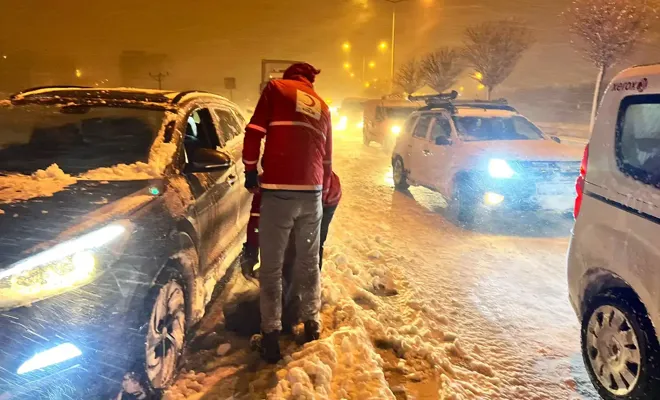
top-left (243, 77), bottom-right (332, 191)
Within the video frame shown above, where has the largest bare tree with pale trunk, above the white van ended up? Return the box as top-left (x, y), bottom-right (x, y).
top-left (563, 0), bottom-right (656, 128)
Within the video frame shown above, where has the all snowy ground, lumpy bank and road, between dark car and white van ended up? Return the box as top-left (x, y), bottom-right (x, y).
top-left (165, 135), bottom-right (597, 400)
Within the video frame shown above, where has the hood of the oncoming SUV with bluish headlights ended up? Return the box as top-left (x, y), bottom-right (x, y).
top-left (461, 140), bottom-right (584, 161)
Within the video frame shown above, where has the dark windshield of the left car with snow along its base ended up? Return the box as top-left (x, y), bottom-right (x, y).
top-left (0, 107), bottom-right (176, 204)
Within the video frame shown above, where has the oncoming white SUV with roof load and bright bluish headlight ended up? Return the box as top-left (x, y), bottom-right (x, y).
top-left (392, 92), bottom-right (582, 223)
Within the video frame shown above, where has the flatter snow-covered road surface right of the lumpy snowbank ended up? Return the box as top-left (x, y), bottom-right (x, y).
top-left (332, 133), bottom-right (597, 399)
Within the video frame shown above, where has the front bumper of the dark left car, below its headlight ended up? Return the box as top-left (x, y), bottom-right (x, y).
top-left (0, 267), bottom-right (149, 399)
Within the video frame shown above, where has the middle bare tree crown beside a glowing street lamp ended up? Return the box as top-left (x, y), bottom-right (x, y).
top-left (463, 19), bottom-right (534, 100)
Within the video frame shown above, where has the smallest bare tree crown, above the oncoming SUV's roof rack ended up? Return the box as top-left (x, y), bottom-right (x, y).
top-left (421, 47), bottom-right (465, 93)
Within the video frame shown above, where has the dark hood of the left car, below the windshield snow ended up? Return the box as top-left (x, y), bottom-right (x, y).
top-left (0, 181), bottom-right (155, 270)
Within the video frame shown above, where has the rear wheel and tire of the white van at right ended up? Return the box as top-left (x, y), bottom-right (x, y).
top-left (581, 291), bottom-right (660, 400)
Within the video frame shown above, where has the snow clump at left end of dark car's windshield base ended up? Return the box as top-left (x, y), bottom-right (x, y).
top-left (0, 164), bottom-right (76, 204)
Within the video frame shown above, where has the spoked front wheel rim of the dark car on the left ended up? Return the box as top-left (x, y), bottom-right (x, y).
top-left (145, 271), bottom-right (187, 390)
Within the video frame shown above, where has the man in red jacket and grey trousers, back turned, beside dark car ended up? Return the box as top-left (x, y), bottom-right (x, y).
top-left (243, 63), bottom-right (332, 363)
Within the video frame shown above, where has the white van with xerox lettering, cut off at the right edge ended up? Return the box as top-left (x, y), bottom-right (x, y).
top-left (568, 65), bottom-right (660, 400)
